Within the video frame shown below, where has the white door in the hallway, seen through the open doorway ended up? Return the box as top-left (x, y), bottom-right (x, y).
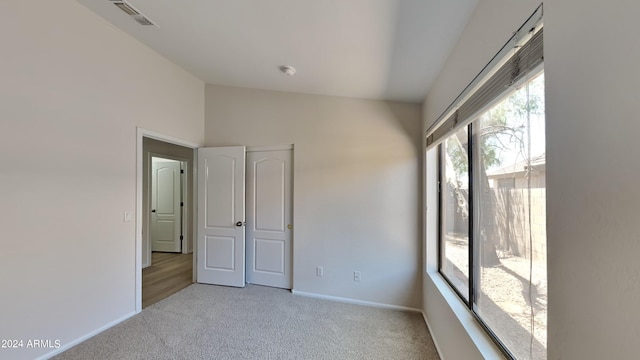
top-left (150, 160), bottom-right (182, 252)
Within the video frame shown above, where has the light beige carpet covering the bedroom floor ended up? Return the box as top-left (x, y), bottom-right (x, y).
top-left (54, 284), bottom-right (439, 360)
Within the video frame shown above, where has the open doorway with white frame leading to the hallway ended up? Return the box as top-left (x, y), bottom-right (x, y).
top-left (136, 129), bottom-right (196, 311)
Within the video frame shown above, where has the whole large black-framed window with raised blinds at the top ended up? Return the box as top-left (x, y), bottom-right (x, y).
top-left (427, 6), bottom-right (547, 359)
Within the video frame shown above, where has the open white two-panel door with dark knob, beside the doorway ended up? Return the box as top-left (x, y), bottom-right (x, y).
top-left (197, 146), bottom-right (245, 287)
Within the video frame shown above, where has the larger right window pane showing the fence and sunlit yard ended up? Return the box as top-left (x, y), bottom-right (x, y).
top-left (473, 74), bottom-right (547, 359)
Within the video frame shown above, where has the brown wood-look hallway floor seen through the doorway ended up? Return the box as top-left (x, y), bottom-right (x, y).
top-left (142, 252), bottom-right (193, 308)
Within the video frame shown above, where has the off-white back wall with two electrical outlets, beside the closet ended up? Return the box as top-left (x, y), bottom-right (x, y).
top-left (205, 85), bottom-right (422, 308)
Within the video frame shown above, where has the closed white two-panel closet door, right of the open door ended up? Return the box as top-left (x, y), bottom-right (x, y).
top-left (246, 149), bottom-right (292, 289)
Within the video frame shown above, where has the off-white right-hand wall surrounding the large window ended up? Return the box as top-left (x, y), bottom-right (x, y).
top-left (424, 0), bottom-right (640, 359)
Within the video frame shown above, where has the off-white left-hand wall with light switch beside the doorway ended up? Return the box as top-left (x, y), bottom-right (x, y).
top-left (0, 0), bottom-right (204, 359)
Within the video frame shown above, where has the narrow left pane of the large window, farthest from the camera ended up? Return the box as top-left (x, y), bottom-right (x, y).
top-left (440, 128), bottom-right (469, 300)
